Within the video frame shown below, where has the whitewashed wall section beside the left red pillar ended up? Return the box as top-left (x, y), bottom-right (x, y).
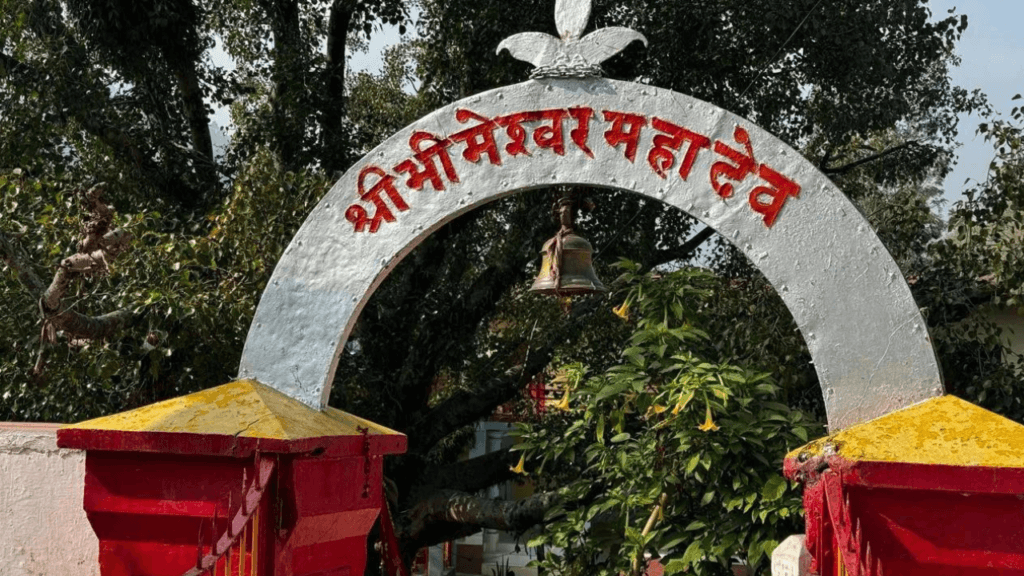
top-left (0, 422), bottom-right (99, 576)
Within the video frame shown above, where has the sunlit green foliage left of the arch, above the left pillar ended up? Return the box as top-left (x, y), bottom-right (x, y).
top-left (0, 154), bottom-right (328, 421)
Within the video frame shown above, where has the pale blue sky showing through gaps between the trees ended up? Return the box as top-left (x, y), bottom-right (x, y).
top-left (214, 0), bottom-right (1024, 210)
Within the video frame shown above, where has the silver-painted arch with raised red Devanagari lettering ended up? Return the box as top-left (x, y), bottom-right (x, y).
top-left (240, 79), bottom-right (943, 429)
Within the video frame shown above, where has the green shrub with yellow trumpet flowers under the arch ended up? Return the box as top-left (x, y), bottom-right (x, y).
top-left (517, 263), bottom-right (823, 576)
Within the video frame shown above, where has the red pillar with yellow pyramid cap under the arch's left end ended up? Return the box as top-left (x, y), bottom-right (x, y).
top-left (57, 380), bottom-right (406, 576)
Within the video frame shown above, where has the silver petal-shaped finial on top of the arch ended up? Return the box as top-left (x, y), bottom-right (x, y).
top-left (498, 0), bottom-right (647, 78)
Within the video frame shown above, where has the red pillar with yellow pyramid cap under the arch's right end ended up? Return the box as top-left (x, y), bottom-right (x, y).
top-left (784, 396), bottom-right (1024, 576)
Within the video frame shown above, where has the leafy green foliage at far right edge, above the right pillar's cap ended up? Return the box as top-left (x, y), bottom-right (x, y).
top-left (915, 95), bottom-right (1024, 422)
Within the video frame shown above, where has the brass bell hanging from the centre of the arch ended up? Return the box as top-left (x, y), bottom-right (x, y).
top-left (529, 198), bottom-right (608, 296)
